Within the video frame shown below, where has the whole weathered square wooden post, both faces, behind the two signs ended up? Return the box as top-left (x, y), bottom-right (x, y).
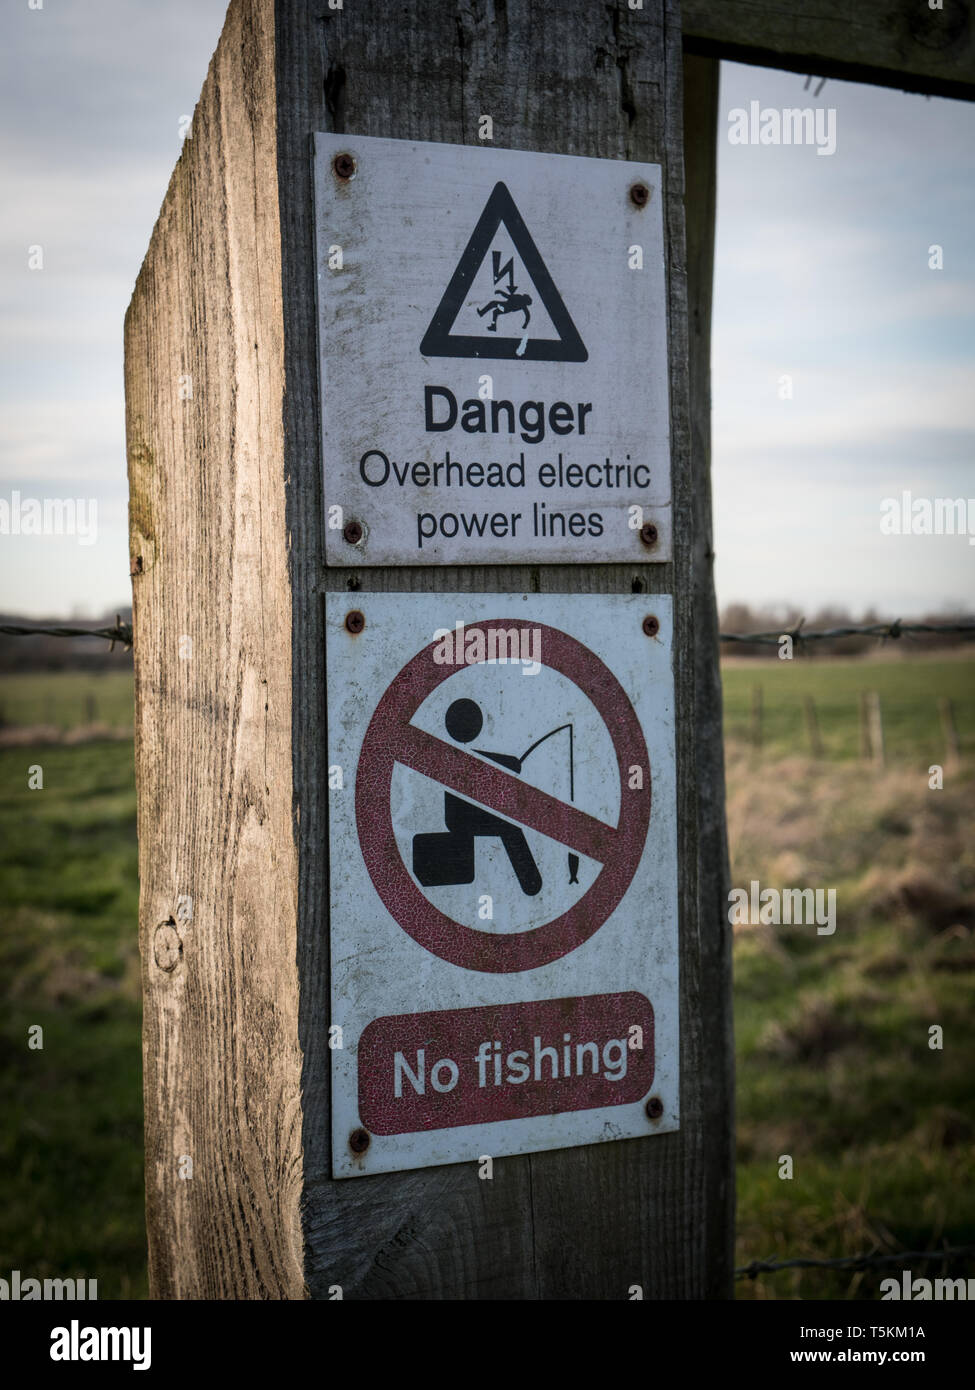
top-left (125, 0), bottom-right (733, 1298)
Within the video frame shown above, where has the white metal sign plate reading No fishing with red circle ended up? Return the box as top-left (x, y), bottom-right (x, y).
top-left (325, 594), bottom-right (679, 1177)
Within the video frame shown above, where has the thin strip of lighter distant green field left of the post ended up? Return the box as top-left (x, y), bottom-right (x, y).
top-left (0, 670), bottom-right (132, 728)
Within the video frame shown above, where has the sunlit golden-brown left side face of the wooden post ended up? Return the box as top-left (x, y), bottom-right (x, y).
top-left (125, 0), bottom-right (303, 1298)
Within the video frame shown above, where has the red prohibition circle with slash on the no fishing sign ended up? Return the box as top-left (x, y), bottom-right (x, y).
top-left (356, 619), bottom-right (651, 974)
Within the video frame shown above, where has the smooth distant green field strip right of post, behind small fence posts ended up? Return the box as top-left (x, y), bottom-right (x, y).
top-left (722, 655), bottom-right (975, 767)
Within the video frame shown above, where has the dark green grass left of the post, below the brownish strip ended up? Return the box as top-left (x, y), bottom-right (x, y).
top-left (0, 742), bottom-right (146, 1298)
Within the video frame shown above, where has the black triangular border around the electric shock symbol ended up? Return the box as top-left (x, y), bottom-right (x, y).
top-left (420, 182), bottom-right (588, 361)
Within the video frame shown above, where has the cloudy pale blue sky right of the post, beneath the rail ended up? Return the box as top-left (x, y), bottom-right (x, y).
top-left (712, 64), bottom-right (975, 616)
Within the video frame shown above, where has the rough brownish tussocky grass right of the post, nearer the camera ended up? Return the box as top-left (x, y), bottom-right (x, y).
top-left (727, 745), bottom-right (975, 1298)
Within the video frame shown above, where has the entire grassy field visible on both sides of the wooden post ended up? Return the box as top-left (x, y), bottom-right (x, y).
top-left (0, 659), bottom-right (975, 1298)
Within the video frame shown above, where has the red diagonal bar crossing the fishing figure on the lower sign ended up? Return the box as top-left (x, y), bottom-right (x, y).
top-left (391, 724), bottom-right (619, 865)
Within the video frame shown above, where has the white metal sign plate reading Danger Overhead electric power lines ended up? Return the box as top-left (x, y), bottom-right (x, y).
top-left (314, 135), bottom-right (672, 566)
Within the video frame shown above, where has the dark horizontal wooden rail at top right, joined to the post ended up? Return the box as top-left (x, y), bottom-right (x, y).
top-left (682, 0), bottom-right (975, 101)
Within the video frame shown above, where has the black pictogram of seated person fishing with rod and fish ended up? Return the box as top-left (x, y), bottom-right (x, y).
top-left (413, 699), bottom-right (579, 898)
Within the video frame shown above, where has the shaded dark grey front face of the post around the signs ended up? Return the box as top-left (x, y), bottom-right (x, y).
top-left (277, 0), bottom-right (732, 1298)
